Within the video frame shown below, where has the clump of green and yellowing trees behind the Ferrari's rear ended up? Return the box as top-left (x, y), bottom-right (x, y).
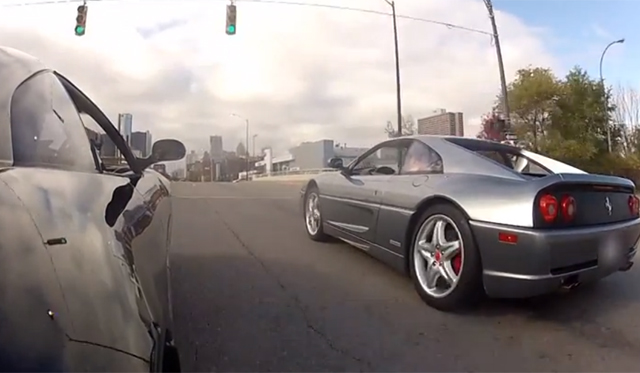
top-left (490, 67), bottom-right (640, 179)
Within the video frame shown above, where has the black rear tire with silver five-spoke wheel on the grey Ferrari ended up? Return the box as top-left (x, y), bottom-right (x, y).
top-left (408, 203), bottom-right (485, 312)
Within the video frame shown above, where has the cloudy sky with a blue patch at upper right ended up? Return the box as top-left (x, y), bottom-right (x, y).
top-left (0, 0), bottom-right (640, 157)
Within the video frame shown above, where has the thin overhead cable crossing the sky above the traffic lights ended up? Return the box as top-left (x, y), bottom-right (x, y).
top-left (0, 0), bottom-right (493, 37)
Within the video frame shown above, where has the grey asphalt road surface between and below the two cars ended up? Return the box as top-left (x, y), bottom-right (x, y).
top-left (172, 182), bottom-right (640, 372)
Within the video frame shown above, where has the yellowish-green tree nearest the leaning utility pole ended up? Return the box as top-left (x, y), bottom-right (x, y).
top-left (498, 67), bottom-right (560, 151)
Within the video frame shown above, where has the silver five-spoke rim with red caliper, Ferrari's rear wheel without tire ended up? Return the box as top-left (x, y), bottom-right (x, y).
top-left (413, 214), bottom-right (464, 298)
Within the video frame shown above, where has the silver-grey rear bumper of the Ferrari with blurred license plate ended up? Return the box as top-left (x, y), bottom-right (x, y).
top-left (470, 219), bottom-right (640, 298)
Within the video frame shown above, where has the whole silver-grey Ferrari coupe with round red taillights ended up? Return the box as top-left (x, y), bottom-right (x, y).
top-left (302, 136), bottom-right (640, 311)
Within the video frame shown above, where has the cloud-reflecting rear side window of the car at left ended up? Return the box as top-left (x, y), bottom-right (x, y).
top-left (11, 72), bottom-right (95, 172)
